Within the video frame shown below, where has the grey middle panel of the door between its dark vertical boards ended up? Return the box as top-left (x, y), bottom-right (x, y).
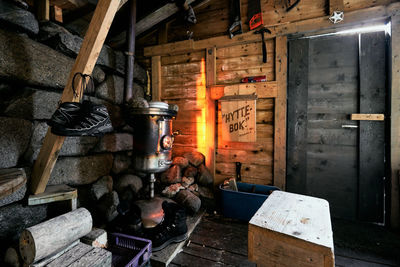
top-left (307, 35), bottom-right (358, 222)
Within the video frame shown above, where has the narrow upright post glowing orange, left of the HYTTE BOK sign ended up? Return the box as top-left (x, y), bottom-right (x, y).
top-left (205, 47), bottom-right (217, 185)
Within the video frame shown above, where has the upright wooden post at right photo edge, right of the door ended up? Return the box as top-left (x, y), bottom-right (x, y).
top-left (390, 15), bottom-right (400, 228)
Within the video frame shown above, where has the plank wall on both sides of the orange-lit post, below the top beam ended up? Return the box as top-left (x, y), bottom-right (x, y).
top-left (160, 39), bottom-right (275, 184)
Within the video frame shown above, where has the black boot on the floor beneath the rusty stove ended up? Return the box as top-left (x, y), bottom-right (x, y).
top-left (147, 201), bottom-right (187, 251)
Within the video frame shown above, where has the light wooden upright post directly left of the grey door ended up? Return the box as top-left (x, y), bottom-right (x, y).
top-left (274, 36), bottom-right (287, 190)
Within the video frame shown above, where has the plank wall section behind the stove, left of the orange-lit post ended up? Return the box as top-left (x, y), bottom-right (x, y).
top-left (160, 51), bottom-right (206, 156)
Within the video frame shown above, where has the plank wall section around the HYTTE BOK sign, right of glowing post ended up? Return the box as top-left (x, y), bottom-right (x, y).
top-left (215, 39), bottom-right (275, 185)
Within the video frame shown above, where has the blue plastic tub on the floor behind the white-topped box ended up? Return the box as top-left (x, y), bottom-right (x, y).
top-left (219, 183), bottom-right (280, 222)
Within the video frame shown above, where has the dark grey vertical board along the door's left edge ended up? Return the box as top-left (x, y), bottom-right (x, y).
top-left (286, 39), bottom-right (309, 193)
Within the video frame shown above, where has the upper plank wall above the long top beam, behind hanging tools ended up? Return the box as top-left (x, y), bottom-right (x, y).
top-left (138, 0), bottom-right (396, 46)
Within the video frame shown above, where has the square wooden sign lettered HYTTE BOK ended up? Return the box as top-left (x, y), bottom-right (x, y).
top-left (221, 95), bottom-right (256, 142)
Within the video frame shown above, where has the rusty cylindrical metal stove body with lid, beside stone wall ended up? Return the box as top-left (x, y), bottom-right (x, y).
top-left (130, 102), bottom-right (177, 173)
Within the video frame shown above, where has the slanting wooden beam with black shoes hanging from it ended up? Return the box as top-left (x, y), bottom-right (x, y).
top-left (31, 0), bottom-right (120, 194)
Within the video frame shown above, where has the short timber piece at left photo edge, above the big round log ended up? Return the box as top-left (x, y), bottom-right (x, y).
top-left (0, 168), bottom-right (26, 199)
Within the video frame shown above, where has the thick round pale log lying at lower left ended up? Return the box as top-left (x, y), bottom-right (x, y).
top-left (19, 208), bottom-right (92, 264)
